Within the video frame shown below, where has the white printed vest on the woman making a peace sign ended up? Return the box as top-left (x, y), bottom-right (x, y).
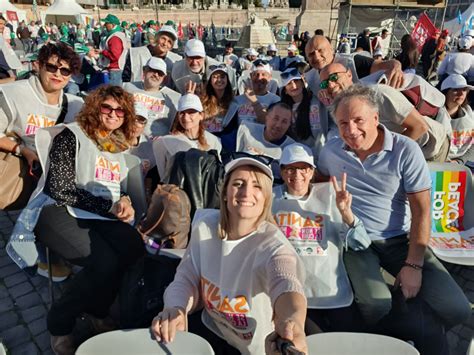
top-left (272, 183), bottom-right (353, 308)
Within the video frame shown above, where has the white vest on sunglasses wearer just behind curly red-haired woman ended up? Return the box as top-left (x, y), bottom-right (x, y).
top-left (123, 83), bottom-right (181, 137)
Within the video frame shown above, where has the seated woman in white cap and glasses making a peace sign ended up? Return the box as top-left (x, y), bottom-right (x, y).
top-left (272, 143), bottom-right (370, 334)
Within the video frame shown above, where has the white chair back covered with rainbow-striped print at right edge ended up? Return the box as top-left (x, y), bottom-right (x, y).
top-left (428, 163), bottom-right (474, 265)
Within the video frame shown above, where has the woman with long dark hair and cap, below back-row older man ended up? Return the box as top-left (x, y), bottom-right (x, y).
top-left (201, 64), bottom-right (234, 136)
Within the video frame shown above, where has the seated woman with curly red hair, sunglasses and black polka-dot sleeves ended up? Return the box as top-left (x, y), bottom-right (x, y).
top-left (27, 86), bottom-right (144, 354)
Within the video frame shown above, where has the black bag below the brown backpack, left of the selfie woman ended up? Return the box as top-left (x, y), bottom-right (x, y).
top-left (119, 255), bottom-right (181, 329)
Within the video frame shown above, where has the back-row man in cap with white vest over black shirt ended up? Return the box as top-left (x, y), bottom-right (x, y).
top-left (123, 25), bottom-right (182, 87)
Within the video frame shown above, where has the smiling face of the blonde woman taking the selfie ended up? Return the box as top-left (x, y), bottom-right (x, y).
top-left (226, 166), bottom-right (265, 226)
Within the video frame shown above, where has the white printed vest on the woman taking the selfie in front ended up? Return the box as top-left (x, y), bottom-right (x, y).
top-left (188, 210), bottom-right (304, 354)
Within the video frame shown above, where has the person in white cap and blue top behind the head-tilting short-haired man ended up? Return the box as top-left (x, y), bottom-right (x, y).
top-left (224, 59), bottom-right (280, 126)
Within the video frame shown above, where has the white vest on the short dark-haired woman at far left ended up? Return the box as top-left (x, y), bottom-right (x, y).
top-left (0, 77), bottom-right (83, 151)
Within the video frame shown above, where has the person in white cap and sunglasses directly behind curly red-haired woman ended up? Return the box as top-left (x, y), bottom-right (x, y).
top-left (123, 57), bottom-right (180, 138)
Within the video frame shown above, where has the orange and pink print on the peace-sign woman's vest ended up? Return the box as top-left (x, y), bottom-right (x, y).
top-left (273, 212), bottom-right (327, 256)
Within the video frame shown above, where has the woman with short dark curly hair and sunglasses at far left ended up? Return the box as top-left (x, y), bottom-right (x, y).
top-left (0, 43), bottom-right (83, 178)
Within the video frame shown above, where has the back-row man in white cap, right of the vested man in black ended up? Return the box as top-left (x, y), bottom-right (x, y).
top-left (171, 39), bottom-right (236, 95)
